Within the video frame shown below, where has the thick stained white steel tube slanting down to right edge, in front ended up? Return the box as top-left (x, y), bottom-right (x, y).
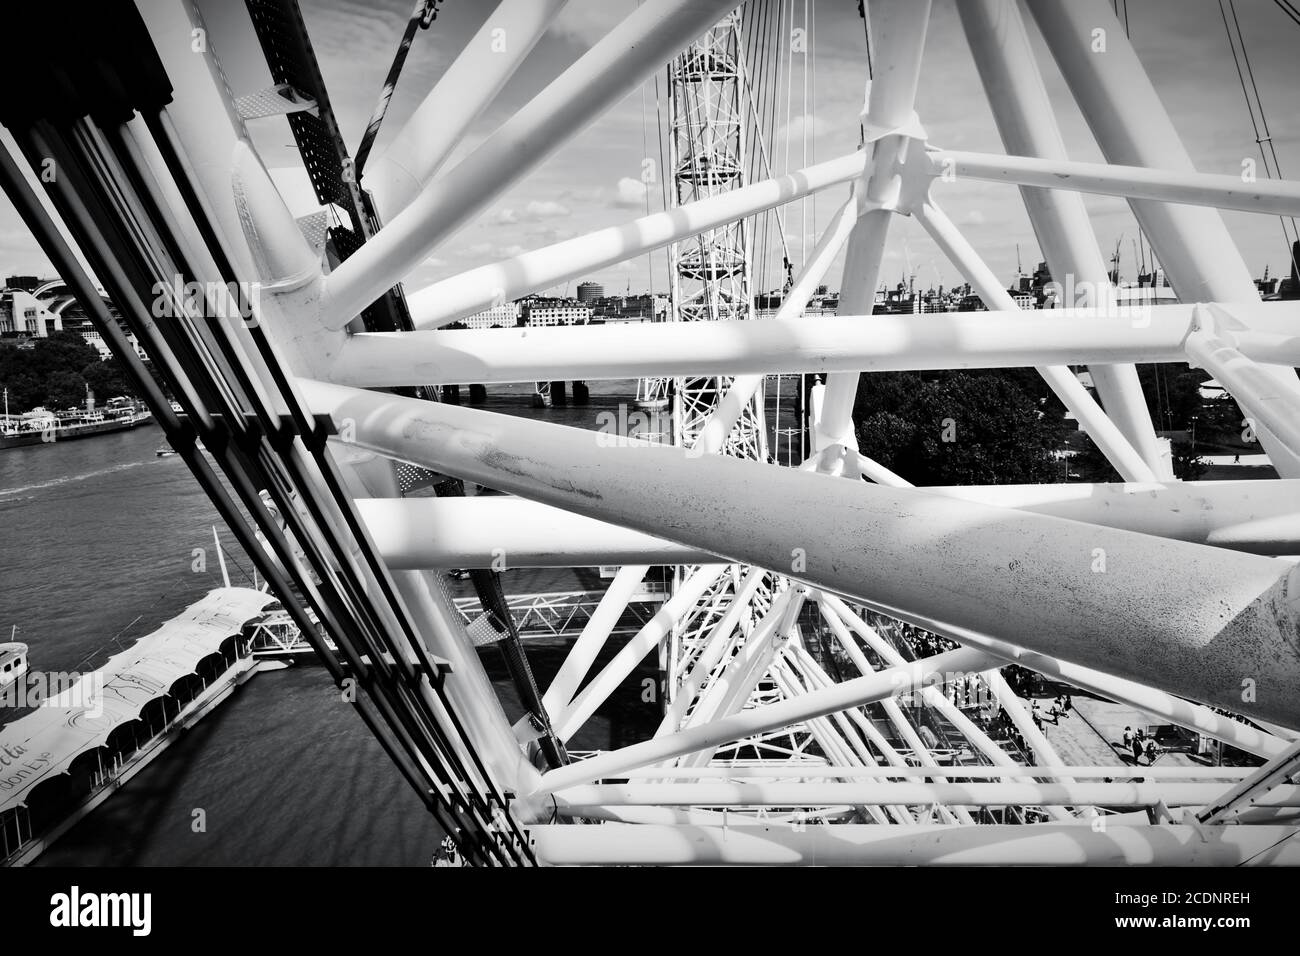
top-left (300, 381), bottom-right (1300, 724)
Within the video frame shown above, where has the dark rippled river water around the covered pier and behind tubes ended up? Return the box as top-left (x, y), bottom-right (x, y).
top-left (0, 381), bottom-right (793, 865)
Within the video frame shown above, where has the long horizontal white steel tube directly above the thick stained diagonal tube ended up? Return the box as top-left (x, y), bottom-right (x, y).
top-left (329, 302), bottom-right (1300, 387)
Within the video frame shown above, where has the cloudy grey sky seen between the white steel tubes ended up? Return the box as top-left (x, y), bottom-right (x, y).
top-left (0, 0), bottom-right (1300, 294)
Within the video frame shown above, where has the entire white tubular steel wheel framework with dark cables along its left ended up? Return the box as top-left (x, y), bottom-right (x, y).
top-left (0, 0), bottom-right (1300, 865)
